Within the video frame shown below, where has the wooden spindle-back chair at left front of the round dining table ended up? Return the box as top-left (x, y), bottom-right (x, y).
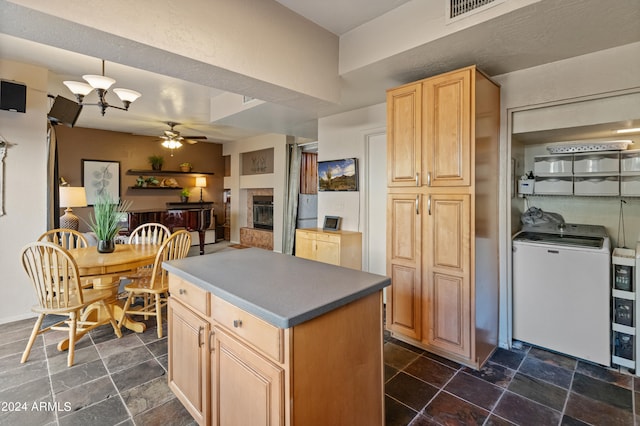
top-left (20, 241), bottom-right (122, 367)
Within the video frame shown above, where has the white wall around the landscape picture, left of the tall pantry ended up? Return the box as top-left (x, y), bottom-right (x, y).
top-left (318, 103), bottom-right (387, 270)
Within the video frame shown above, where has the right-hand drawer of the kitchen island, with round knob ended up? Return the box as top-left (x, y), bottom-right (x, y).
top-left (211, 295), bottom-right (284, 362)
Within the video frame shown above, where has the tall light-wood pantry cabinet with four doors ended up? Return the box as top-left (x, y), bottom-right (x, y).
top-left (386, 66), bottom-right (500, 369)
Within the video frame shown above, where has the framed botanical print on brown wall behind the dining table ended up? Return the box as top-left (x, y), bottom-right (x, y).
top-left (82, 160), bottom-right (120, 206)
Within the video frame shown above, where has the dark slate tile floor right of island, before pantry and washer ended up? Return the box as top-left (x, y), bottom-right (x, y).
top-left (384, 336), bottom-right (640, 426)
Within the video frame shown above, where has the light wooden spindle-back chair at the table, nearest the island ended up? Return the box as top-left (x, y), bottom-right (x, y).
top-left (118, 229), bottom-right (191, 338)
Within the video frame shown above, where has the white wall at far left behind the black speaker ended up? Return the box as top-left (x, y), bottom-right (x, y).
top-left (0, 60), bottom-right (49, 323)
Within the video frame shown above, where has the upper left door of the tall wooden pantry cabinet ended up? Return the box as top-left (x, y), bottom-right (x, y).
top-left (387, 83), bottom-right (422, 187)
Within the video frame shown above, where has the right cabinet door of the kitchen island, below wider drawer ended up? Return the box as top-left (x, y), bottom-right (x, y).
top-left (211, 326), bottom-right (285, 426)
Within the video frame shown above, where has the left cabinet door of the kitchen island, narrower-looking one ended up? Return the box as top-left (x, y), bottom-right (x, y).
top-left (167, 298), bottom-right (210, 425)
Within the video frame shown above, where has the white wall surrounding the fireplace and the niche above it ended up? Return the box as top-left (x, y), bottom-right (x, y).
top-left (222, 134), bottom-right (287, 253)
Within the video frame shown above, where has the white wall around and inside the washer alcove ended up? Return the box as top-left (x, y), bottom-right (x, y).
top-left (494, 43), bottom-right (640, 347)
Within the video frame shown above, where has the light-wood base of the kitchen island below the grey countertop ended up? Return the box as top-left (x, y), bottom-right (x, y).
top-left (168, 274), bottom-right (384, 425)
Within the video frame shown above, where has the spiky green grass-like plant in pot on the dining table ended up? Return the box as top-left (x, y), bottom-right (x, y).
top-left (89, 193), bottom-right (131, 253)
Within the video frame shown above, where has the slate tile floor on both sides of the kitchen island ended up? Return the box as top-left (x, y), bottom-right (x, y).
top-left (0, 314), bottom-right (640, 426)
